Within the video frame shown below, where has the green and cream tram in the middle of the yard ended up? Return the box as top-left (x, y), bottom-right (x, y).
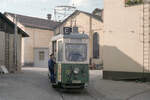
top-left (49, 27), bottom-right (89, 88)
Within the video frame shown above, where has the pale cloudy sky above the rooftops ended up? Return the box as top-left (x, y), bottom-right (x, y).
top-left (0, 0), bottom-right (103, 18)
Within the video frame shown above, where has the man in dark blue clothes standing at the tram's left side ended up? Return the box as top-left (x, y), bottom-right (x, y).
top-left (48, 54), bottom-right (56, 83)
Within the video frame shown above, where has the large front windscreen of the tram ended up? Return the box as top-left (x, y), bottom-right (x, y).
top-left (66, 44), bottom-right (87, 62)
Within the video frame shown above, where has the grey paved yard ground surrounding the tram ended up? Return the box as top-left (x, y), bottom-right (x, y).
top-left (0, 68), bottom-right (150, 100)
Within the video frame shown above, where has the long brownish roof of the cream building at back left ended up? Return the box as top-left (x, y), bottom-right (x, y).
top-left (5, 12), bottom-right (59, 30)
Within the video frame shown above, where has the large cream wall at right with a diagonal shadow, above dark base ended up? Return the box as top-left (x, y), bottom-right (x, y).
top-left (103, 0), bottom-right (143, 72)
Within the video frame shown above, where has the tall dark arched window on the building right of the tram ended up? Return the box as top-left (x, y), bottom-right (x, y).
top-left (93, 32), bottom-right (99, 58)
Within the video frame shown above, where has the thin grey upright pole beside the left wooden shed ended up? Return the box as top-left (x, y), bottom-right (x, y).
top-left (14, 14), bottom-right (18, 71)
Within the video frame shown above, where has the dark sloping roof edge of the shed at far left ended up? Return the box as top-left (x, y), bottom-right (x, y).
top-left (0, 13), bottom-right (29, 37)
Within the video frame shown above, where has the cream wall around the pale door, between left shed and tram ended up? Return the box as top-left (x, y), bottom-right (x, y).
top-left (23, 27), bottom-right (54, 65)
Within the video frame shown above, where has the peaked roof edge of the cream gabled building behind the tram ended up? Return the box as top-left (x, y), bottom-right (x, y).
top-left (57, 10), bottom-right (103, 27)
